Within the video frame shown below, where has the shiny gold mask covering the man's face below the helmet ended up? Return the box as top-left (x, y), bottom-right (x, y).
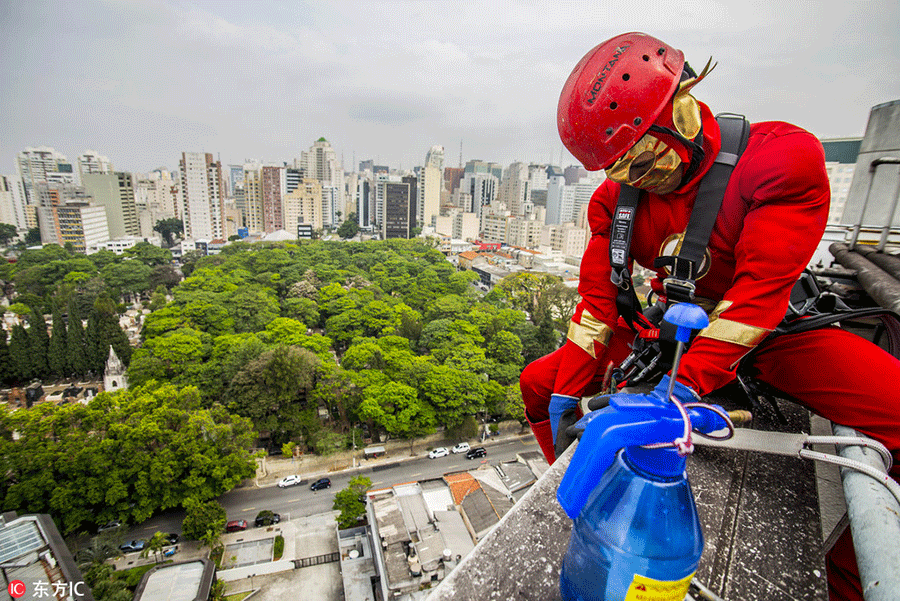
top-left (606, 134), bottom-right (681, 191)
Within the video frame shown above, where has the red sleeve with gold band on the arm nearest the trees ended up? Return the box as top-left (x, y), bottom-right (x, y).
top-left (553, 180), bottom-right (619, 396)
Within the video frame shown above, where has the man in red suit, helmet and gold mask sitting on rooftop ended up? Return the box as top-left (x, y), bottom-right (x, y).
top-left (520, 33), bottom-right (900, 599)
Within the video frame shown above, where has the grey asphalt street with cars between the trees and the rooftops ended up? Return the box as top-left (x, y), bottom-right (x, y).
top-left (132, 437), bottom-right (539, 539)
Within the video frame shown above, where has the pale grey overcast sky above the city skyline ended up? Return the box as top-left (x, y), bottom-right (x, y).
top-left (0, 0), bottom-right (900, 174)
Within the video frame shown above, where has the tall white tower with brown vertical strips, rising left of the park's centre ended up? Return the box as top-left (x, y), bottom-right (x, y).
top-left (179, 152), bottom-right (225, 240)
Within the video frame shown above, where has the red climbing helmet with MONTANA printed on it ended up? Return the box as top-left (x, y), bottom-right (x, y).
top-left (556, 33), bottom-right (684, 171)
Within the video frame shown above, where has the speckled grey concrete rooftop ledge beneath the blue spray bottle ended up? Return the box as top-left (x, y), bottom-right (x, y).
top-left (427, 400), bottom-right (828, 601)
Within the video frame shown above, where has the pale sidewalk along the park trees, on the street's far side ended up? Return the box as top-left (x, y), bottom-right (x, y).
top-left (241, 421), bottom-right (532, 488)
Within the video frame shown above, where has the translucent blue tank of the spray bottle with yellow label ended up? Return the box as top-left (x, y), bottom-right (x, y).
top-left (560, 447), bottom-right (703, 601)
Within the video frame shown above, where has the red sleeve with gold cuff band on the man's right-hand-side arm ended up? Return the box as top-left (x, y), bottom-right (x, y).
top-left (678, 129), bottom-right (830, 394)
